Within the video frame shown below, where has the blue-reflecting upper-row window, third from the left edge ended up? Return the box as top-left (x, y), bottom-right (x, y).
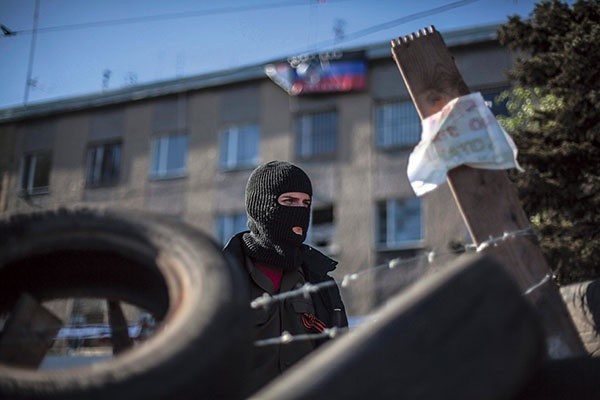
top-left (150, 134), bottom-right (188, 178)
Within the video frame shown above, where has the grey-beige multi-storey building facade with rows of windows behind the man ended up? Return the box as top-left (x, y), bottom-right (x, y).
top-left (0, 26), bottom-right (512, 314)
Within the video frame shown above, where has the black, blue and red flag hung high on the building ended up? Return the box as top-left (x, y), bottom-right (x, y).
top-left (264, 51), bottom-right (367, 96)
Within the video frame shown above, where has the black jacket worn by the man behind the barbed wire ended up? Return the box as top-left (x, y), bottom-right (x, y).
top-left (224, 232), bottom-right (348, 391)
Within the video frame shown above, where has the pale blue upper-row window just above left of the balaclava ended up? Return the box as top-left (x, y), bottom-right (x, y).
top-left (219, 124), bottom-right (260, 170)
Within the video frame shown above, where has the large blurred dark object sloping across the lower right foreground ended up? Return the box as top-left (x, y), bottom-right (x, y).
top-left (251, 254), bottom-right (544, 400)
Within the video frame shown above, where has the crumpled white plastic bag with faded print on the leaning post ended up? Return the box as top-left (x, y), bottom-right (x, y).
top-left (407, 93), bottom-right (522, 196)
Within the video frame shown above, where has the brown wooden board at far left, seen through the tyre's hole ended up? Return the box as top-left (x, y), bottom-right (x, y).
top-left (0, 293), bottom-right (63, 368)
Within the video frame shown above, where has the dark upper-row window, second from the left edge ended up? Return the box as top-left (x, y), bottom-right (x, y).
top-left (85, 143), bottom-right (121, 187)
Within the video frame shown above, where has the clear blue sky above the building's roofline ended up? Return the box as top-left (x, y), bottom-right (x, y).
top-left (0, 0), bottom-right (552, 108)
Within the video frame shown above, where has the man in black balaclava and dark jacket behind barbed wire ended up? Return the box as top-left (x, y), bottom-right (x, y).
top-left (224, 161), bottom-right (348, 392)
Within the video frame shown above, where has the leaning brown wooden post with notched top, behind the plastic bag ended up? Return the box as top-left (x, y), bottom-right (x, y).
top-left (392, 27), bottom-right (586, 358)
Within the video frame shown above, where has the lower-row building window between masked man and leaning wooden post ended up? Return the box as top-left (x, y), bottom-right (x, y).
top-left (376, 197), bottom-right (423, 249)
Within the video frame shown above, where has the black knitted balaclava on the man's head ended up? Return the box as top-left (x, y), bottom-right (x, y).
top-left (243, 161), bottom-right (312, 270)
